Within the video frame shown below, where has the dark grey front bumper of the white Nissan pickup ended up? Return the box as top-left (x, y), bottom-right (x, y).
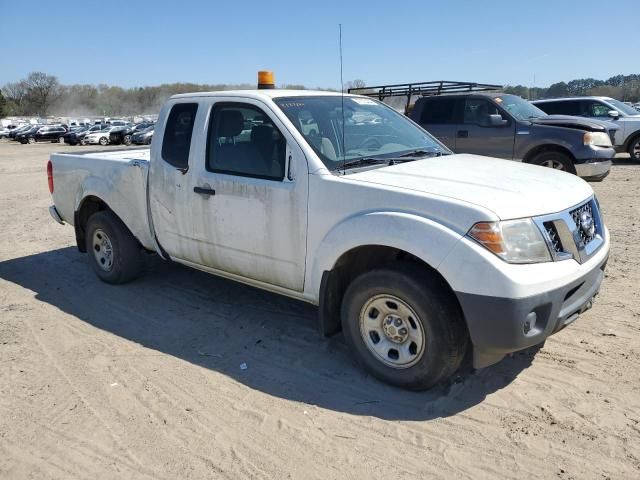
top-left (456, 256), bottom-right (608, 368)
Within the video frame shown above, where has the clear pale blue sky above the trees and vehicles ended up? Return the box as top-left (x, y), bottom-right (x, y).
top-left (0, 0), bottom-right (640, 88)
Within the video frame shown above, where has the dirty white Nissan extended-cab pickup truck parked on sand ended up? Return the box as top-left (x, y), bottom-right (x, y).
top-left (47, 90), bottom-right (609, 389)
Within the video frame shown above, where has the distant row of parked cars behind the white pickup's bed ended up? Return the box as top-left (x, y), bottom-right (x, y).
top-left (0, 122), bottom-right (154, 145)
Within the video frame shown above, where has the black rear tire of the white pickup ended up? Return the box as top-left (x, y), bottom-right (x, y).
top-left (85, 210), bottom-right (142, 284)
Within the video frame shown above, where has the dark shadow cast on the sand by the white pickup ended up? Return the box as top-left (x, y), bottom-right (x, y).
top-left (0, 247), bottom-right (537, 420)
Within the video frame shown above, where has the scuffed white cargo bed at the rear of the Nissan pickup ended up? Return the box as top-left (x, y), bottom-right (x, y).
top-left (51, 148), bottom-right (154, 249)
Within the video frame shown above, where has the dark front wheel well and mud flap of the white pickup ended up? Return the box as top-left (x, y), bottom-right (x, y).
top-left (319, 245), bottom-right (457, 336)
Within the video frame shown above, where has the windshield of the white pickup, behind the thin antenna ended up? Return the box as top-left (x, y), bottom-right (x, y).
top-left (274, 95), bottom-right (451, 170)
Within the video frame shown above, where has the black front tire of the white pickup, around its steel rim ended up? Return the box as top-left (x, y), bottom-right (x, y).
top-left (341, 264), bottom-right (468, 390)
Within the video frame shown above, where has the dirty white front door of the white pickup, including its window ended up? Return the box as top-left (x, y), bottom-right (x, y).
top-left (188, 97), bottom-right (308, 291)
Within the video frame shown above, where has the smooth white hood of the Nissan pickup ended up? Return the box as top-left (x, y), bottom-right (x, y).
top-left (347, 154), bottom-right (593, 220)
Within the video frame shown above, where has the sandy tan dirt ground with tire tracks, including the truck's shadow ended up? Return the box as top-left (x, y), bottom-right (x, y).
top-left (0, 142), bottom-right (640, 480)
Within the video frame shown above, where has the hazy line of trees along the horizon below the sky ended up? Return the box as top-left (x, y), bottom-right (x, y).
top-left (0, 72), bottom-right (640, 117)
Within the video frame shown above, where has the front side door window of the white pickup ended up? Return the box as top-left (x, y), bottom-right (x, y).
top-left (206, 102), bottom-right (286, 180)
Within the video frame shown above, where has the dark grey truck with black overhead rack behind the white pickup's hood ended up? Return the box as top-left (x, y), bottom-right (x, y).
top-left (350, 82), bottom-right (618, 181)
